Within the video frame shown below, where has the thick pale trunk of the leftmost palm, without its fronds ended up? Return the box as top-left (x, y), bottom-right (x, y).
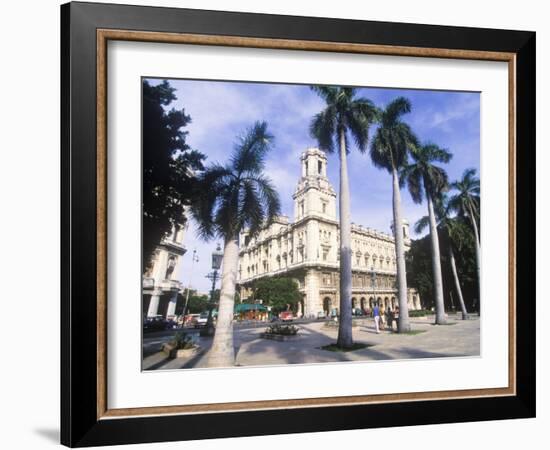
top-left (207, 237), bottom-right (239, 367)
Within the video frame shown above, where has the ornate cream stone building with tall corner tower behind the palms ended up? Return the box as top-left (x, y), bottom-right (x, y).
top-left (238, 148), bottom-right (420, 317)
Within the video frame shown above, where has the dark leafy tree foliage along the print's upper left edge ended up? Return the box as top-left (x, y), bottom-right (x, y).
top-left (142, 80), bottom-right (205, 268)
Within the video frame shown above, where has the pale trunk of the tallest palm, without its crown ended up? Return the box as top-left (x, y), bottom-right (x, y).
top-left (337, 130), bottom-right (353, 348)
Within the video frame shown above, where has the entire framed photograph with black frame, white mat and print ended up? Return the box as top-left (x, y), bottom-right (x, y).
top-left (61, 3), bottom-right (536, 447)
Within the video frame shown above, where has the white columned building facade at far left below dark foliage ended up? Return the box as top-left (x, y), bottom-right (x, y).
top-left (142, 226), bottom-right (186, 317)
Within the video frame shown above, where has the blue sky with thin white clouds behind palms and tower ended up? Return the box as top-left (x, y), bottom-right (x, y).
top-left (149, 79), bottom-right (480, 292)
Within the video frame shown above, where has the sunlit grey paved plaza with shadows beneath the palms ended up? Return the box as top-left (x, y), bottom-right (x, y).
top-left (143, 315), bottom-right (480, 370)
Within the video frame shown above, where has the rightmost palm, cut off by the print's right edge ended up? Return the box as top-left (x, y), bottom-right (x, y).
top-left (449, 169), bottom-right (481, 292)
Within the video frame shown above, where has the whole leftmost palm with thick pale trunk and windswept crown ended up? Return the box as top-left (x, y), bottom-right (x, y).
top-left (192, 122), bottom-right (280, 367)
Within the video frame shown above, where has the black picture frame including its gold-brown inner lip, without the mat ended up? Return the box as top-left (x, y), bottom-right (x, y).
top-left (61, 2), bottom-right (536, 447)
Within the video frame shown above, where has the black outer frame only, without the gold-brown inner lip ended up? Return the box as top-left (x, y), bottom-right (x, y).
top-left (61, 3), bottom-right (536, 447)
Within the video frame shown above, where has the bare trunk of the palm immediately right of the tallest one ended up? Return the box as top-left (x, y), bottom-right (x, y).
top-left (392, 167), bottom-right (411, 333)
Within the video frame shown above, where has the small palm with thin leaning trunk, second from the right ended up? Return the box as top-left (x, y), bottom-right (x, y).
top-left (414, 194), bottom-right (468, 320)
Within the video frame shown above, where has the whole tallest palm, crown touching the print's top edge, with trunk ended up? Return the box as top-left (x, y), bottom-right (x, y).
top-left (310, 86), bottom-right (378, 348)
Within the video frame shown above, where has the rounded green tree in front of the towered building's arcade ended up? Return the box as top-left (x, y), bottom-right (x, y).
top-left (253, 277), bottom-right (302, 312)
